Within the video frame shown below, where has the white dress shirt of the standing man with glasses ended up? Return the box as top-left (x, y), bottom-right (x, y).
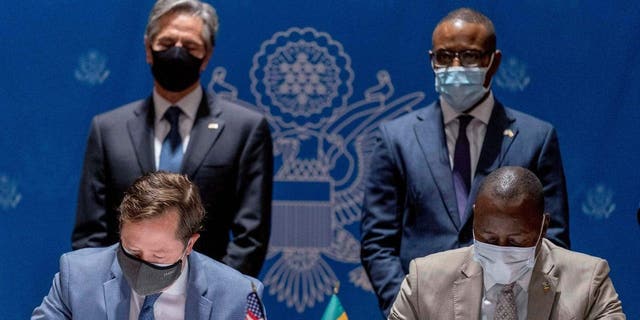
top-left (440, 91), bottom-right (495, 183)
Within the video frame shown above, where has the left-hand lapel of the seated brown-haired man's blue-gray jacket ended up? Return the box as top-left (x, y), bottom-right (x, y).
top-left (102, 255), bottom-right (131, 320)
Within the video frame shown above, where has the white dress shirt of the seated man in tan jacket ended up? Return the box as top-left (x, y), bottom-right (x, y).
top-left (480, 269), bottom-right (533, 320)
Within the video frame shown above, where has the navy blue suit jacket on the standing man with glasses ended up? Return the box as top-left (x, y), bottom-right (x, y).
top-left (361, 101), bottom-right (569, 314)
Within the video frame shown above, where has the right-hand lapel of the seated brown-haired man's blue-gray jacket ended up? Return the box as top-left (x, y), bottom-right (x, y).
top-left (184, 254), bottom-right (213, 319)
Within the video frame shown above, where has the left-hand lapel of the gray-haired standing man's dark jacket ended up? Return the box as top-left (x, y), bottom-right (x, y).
top-left (127, 97), bottom-right (155, 172)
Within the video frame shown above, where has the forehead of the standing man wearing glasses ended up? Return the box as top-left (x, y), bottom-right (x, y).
top-left (433, 20), bottom-right (489, 51)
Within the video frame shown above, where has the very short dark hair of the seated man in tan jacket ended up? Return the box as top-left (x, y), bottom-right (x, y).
top-left (478, 167), bottom-right (544, 215)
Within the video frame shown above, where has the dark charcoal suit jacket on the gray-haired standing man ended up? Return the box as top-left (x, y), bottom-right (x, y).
top-left (72, 94), bottom-right (273, 276)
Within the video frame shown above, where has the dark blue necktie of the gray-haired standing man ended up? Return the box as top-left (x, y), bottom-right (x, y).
top-left (158, 106), bottom-right (182, 172)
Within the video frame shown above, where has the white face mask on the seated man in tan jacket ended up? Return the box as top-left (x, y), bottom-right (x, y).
top-left (473, 216), bottom-right (546, 284)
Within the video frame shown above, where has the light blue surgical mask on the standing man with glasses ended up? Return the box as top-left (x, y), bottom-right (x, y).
top-left (432, 55), bottom-right (493, 113)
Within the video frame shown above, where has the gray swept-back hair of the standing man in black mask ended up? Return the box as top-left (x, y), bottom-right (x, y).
top-left (144, 0), bottom-right (218, 50)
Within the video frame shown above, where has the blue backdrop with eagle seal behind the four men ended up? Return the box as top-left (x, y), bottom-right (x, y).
top-left (0, 0), bottom-right (640, 319)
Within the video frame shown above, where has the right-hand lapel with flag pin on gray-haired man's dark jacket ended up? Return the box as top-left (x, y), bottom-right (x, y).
top-left (182, 94), bottom-right (225, 176)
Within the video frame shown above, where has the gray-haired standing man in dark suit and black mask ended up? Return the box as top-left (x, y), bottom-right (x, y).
top-left (72, 0), bottom-right (273, 276)
